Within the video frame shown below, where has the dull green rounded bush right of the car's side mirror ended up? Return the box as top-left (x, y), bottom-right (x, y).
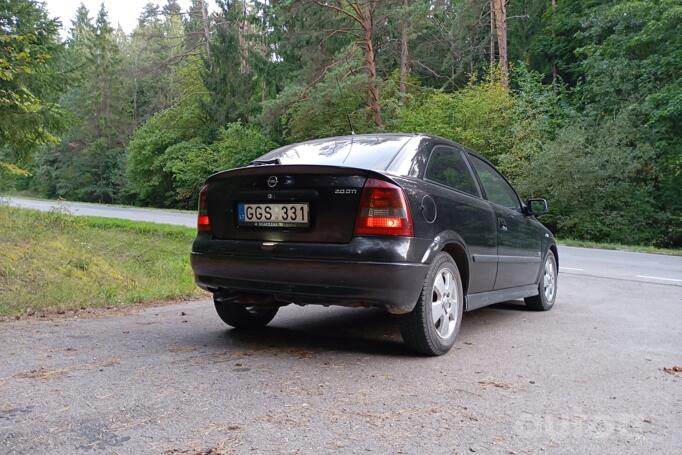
top-left (520, 116), bottom-right (670, 244)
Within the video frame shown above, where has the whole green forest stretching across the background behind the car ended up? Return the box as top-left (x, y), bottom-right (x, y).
top-left (0, 0), bottom-right (682, 248)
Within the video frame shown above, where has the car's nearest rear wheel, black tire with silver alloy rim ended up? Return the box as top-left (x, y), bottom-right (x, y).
top-left (400, 253), bottom-right (464, 356)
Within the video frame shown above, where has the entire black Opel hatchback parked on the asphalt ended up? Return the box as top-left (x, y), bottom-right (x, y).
top-left (192, 134), bottom-right (558, 355)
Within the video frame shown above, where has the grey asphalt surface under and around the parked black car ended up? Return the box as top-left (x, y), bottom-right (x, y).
top-left (0, 195), bottom-right (682, 454)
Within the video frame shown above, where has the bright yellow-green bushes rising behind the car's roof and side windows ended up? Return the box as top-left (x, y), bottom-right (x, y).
top-left (393, 65), bottom-right (561, 181)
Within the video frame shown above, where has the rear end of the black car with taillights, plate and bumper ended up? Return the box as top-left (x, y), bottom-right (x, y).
top-left (192, 134), bottom-right (428, 313)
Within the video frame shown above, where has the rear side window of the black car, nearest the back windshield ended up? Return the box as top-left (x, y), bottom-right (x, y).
top-left (424, 146), bottom-right (479, 196)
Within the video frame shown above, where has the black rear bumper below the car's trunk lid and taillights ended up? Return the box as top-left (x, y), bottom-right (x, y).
top-left (191, 251), bottom-right (428, 314)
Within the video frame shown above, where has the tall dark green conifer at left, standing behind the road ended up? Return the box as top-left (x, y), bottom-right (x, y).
top-left (35, 5), bottom-right (131, 202)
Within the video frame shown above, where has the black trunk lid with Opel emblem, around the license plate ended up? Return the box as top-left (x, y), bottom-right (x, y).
top-left (207, 165), bottom-right (390, 243)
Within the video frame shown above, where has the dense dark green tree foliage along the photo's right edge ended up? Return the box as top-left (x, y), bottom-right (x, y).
top-left (528, 0), bottom-right (682, 246)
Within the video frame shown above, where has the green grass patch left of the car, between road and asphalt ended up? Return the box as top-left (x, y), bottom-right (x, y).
top-left (0, 205), bottom-right (201, 316)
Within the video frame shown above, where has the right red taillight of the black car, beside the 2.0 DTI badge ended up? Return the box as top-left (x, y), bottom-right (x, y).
top-left (355, 179), bottom-right (414, 237)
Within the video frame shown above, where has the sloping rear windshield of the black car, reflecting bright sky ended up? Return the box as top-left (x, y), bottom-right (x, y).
top-left (259, 136), bottom-right (409, 171)
